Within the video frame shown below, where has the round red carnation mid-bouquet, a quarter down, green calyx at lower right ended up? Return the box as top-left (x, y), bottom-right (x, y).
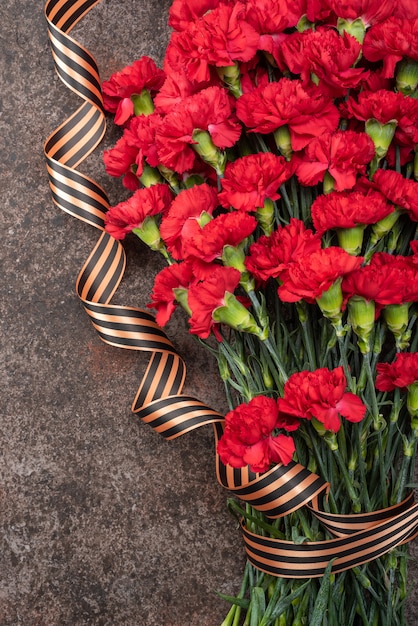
top-left (219, 152), bottom-right (293, 211)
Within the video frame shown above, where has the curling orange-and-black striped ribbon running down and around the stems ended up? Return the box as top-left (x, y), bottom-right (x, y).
top-left (45, 0), bottom-right (418, 578)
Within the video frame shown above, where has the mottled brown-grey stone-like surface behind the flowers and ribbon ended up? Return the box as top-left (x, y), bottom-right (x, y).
top-left (0, 0), bottom-right (418, 626)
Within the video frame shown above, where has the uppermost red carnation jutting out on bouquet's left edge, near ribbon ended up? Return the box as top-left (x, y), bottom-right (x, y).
top-left (102, 56), bottom-right (165, 124)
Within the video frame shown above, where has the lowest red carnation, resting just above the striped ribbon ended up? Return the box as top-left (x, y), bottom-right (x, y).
top-left (217, 396), bottom-right (295, 472)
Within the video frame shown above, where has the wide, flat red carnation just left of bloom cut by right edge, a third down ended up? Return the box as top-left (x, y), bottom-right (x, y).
top-left (311, 190), bottom-right (393, 235)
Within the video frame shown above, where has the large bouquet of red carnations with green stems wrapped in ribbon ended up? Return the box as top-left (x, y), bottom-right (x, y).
top-left (87, 0), bottom-right (418, 626)
